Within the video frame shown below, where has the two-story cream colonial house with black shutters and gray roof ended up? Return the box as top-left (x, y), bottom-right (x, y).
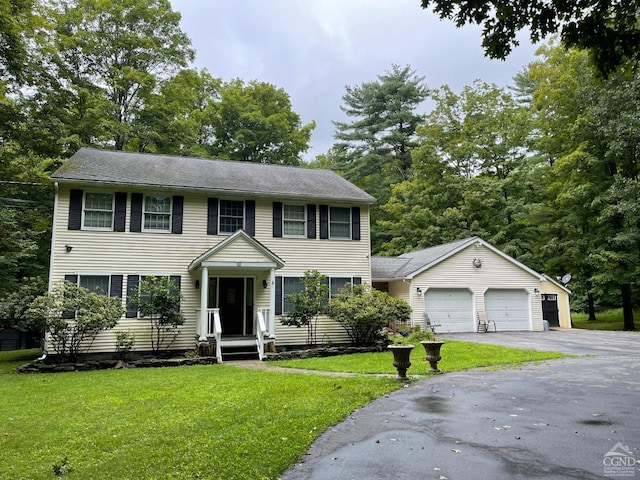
top-left (49, 148), bottom-right (374, 357)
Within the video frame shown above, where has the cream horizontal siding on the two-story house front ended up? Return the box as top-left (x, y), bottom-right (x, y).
top-left (51, 188), bottom-right (371, 352)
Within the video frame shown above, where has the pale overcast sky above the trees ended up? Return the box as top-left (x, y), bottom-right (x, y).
top-left (171, 0), bottom-right (535, 159)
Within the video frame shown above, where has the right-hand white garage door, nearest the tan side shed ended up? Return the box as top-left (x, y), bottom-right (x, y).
top-left (484, 289), bottom-right (531, 332)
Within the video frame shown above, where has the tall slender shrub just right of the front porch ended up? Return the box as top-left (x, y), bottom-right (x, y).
top-left (280, 270), bottom-right (329, 345)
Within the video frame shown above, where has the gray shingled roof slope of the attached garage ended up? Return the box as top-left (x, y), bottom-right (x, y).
top-left (371, 237), bottom-right (477, 281)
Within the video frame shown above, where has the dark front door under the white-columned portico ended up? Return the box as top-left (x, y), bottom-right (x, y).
top-left (209, 277), bottom-right (253, 336)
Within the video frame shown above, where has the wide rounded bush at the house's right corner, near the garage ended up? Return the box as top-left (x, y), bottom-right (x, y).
top-left (329, 284), bottom-right (411, 345)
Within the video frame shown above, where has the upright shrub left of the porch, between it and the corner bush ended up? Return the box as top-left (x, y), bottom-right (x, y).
top-left (129, 277), bottom-right (184, 353)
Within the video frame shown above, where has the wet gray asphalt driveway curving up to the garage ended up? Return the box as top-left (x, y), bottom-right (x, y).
top-left (282, 330), bottom-right (640, 480)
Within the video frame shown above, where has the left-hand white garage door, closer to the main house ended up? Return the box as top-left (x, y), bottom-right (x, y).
top-left (424, 288), bottom-right (473, 332)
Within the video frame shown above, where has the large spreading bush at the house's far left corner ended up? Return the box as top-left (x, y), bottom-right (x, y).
top-left (25, 281), bottom-right (124, 362)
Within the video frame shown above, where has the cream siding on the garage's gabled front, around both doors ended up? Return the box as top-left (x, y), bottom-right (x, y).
top-left (411, 245), bottom-right (543, 331)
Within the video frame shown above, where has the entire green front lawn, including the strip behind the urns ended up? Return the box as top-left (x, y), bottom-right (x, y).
top-left (0, 341), bottom-right (562, 480)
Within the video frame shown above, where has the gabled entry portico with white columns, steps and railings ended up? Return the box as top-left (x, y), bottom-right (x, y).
top-left (189, 230), bottom-right (284, 362)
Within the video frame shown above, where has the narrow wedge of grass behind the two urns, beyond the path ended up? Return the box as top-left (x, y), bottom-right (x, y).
top-left (276, 340), bottom-right (567, 375)
